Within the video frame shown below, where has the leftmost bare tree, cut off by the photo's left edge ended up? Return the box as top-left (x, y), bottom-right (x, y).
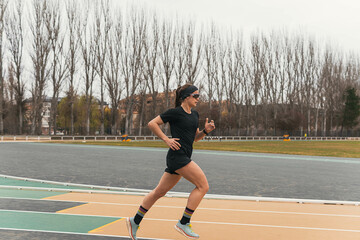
top-left (0, 0), bottom-right (8, 135)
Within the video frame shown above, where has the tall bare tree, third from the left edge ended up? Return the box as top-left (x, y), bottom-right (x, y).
top-left (30, 0), bottom-right (51, 135)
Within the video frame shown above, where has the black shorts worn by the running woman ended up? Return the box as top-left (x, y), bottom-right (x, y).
top-left (165, 149), bottom-right (191, 175)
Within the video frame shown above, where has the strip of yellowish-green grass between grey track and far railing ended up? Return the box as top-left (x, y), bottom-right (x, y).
top-left (48, 141), bottom-right (360, 158)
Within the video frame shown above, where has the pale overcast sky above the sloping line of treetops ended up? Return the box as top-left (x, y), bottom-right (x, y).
top-left (123, 0), bottom-right (360, 53)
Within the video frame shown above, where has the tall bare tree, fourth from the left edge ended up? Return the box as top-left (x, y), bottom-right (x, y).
top-left (46, 1), bottom-right (67, 135)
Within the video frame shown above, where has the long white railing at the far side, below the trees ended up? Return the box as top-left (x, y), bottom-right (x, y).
top-left (0, 135), bottom-right (360, 142)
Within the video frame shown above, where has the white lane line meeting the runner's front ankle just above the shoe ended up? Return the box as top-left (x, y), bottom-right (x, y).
top-left (0, 209), bottom-right (360, 233)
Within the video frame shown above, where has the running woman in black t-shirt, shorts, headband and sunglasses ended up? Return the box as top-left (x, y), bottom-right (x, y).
top-left (126, 83), bottom-right (215, 240)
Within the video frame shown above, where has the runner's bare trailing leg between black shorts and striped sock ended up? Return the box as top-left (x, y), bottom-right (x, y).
top-left (141, 172), bottom-right (181, 210)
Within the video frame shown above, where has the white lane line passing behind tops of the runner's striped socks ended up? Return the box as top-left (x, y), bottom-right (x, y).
top-left (0, 197), bottom-right (360, 218)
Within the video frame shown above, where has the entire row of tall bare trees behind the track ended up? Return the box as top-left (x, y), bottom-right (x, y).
top-left (0, 0), bottom-right (360, 135)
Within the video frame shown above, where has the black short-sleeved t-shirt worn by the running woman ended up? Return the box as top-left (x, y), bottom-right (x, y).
top-left (160, 106), bottom-right (199, 158)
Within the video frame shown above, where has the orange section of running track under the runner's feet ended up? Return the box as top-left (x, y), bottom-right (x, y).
top-left (47, 193), bottom-right (360, 240)
